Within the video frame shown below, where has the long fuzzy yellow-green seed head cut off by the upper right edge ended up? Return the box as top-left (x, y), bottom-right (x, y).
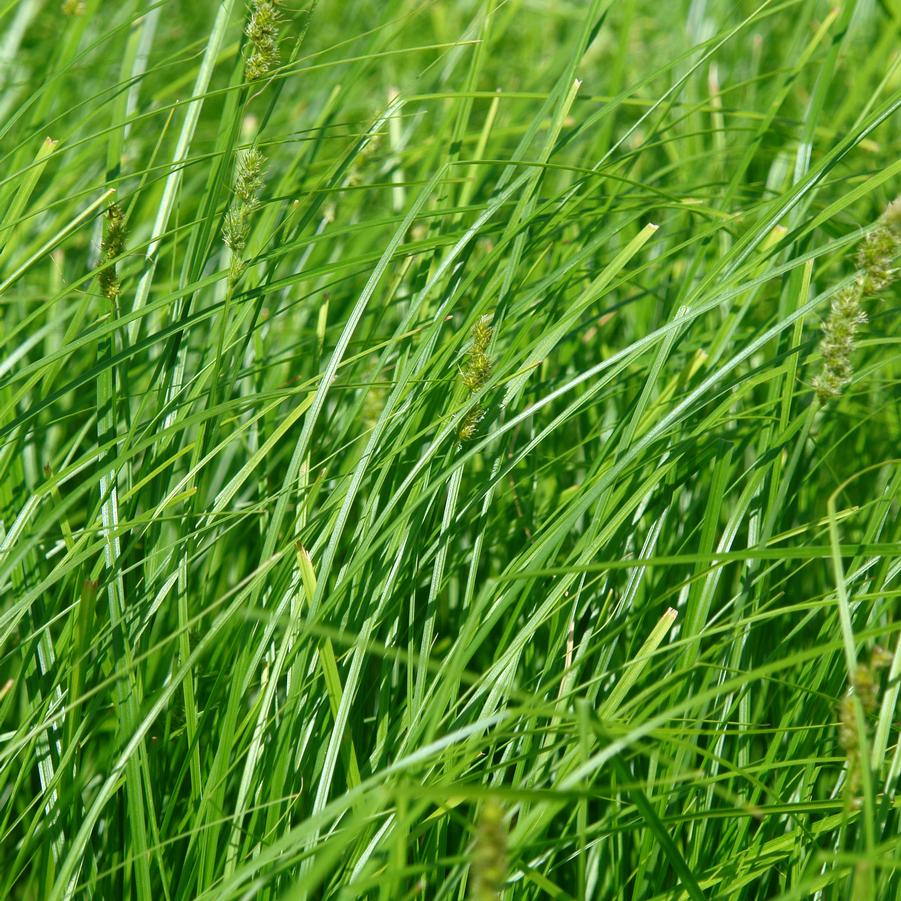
top-left (813, 198), bottom-right (901, 403)
